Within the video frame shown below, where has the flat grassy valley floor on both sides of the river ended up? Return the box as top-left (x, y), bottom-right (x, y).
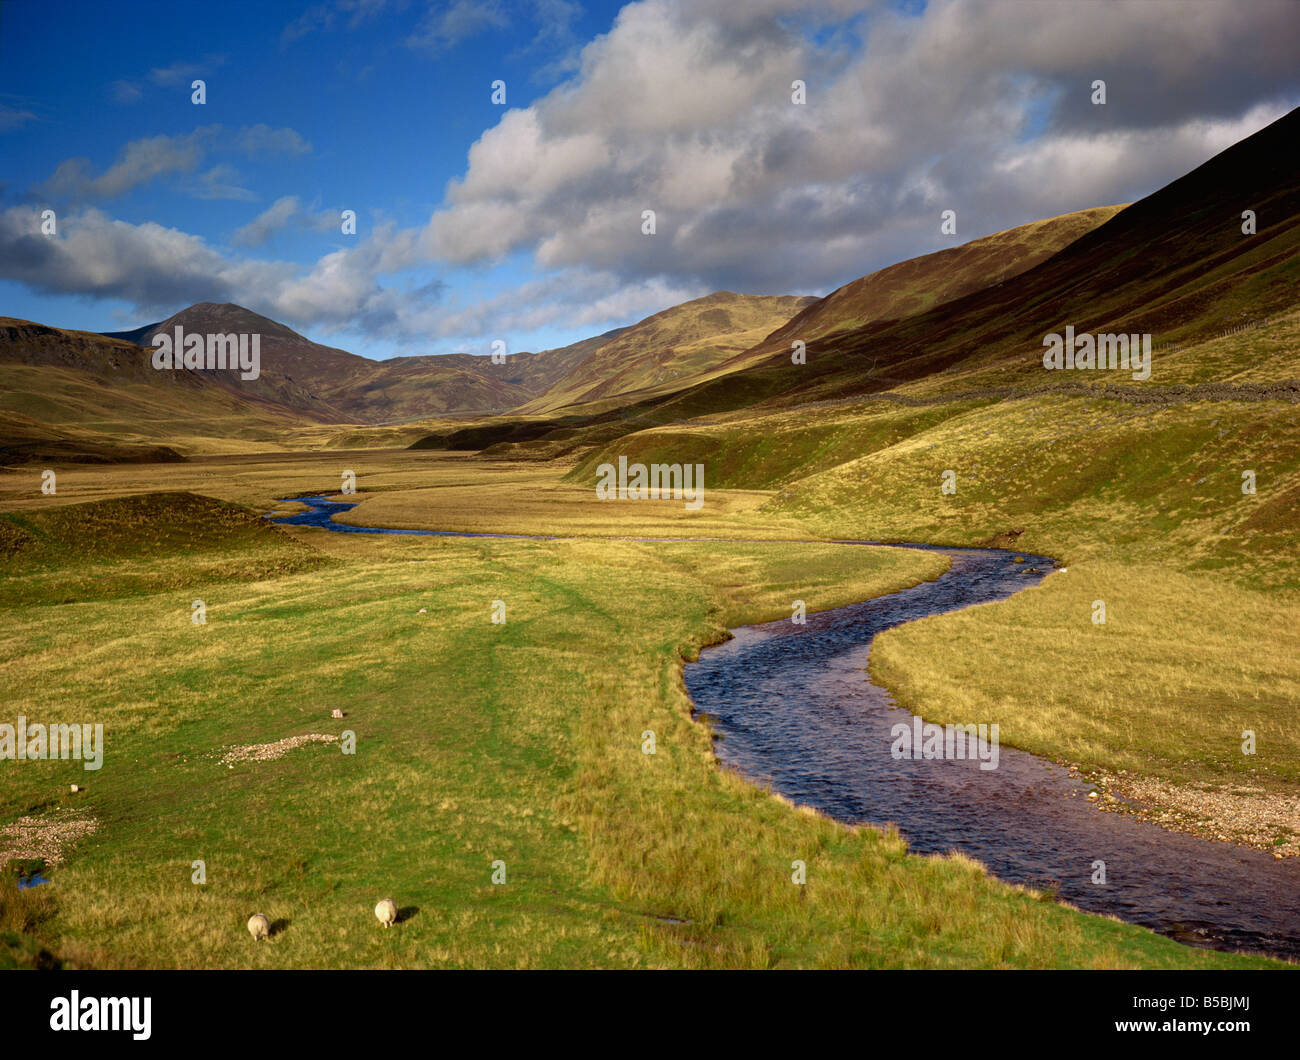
top-left (0, 451), bottom-right (1300, 968)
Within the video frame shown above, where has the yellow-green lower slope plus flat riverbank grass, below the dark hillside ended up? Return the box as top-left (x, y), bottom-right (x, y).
top-left (569, 382), bottom-right (1300, 853)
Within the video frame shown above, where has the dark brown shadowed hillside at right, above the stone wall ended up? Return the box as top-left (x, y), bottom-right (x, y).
top-left (621, 111), bottom-right (1300, 420)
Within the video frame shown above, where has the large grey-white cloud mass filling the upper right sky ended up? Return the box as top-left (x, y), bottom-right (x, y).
top-left (423, 0), bottom-right (1300, 291)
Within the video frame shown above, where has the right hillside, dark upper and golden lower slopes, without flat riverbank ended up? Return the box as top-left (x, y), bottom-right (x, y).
top-left (561, 111), bottom-right (1300, 577)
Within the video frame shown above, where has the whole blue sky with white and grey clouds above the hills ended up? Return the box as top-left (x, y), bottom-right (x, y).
top-left (0, 0), bottom-right (1300, 359)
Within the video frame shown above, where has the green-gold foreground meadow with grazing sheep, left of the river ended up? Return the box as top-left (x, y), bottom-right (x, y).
top-left (0, 494), bottom-right (1262, 968)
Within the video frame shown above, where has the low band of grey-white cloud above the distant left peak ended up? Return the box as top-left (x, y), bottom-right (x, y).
top-left (0, 196), bottom-right (681, 342)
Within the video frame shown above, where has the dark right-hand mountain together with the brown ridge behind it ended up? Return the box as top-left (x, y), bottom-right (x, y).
top-left (431, 109), bottom-right (1300, 465)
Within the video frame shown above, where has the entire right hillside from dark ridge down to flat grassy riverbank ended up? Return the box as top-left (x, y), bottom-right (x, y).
top-left (538, 111), bottom-right (1300, 853)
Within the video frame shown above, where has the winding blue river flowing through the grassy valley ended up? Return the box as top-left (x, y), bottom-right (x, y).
top-left (266, 496), bottom-right (1300, 961)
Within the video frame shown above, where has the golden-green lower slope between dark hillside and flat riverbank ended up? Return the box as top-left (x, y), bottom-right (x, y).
top-left (567, 390), bottom-right (1300, 584)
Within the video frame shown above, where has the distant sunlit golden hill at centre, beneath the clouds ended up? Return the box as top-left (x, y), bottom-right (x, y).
top-left (517, 291), bottom-right (811, 414)
